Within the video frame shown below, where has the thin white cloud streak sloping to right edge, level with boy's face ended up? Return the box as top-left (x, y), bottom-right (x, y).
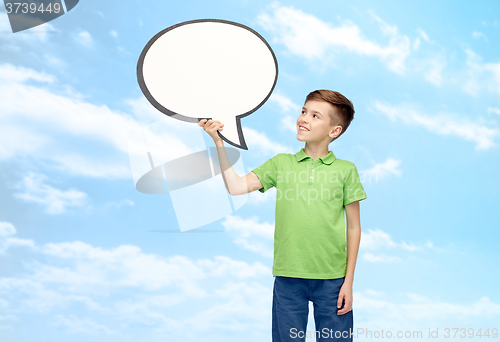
top-left (374, 101), bottom-right (500, 150)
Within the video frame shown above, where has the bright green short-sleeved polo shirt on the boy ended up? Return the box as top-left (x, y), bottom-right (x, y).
top-left (252, 148), bottom-right (366, 279)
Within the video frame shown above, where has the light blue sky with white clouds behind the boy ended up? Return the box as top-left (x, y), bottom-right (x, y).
top-left (0, 0), bottom-right (500, 342)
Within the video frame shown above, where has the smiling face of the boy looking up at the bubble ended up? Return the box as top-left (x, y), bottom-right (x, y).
top-left (297, 100), bottom-right (342, 145)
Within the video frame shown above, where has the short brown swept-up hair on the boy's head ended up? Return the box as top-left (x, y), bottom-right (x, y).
top-left (305, 89), bottom-right (354, 142)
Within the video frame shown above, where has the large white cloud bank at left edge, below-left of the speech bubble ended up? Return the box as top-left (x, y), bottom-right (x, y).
top-left (0, 64), bottom-right (190, 179)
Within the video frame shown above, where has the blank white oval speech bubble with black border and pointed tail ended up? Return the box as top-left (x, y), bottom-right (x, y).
top-left (137, 19), bottom-right (278, 150)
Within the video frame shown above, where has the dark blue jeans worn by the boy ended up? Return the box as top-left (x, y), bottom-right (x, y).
top-left (272, 276), bottom-right (353, 342)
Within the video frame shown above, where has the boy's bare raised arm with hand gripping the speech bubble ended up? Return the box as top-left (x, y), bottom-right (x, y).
top-left (198, 119), bottom-right (262, 196)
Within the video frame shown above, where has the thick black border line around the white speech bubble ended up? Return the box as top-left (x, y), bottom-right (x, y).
top-left (137, 19), bottom-right (278, 150)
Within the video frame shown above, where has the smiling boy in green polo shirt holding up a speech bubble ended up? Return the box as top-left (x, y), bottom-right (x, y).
top-left (198, 90), bottom-right (366, 342)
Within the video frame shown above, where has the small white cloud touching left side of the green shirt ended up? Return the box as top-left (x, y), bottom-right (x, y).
top-left (222, 215), bottom-right (274, 258)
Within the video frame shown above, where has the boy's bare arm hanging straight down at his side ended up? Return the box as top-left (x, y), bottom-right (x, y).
top-left (337, 201), bottom-right (361, 315)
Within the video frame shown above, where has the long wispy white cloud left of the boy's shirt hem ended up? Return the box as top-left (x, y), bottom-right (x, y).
top-left (33, 241), bottom-right (270, 297)
